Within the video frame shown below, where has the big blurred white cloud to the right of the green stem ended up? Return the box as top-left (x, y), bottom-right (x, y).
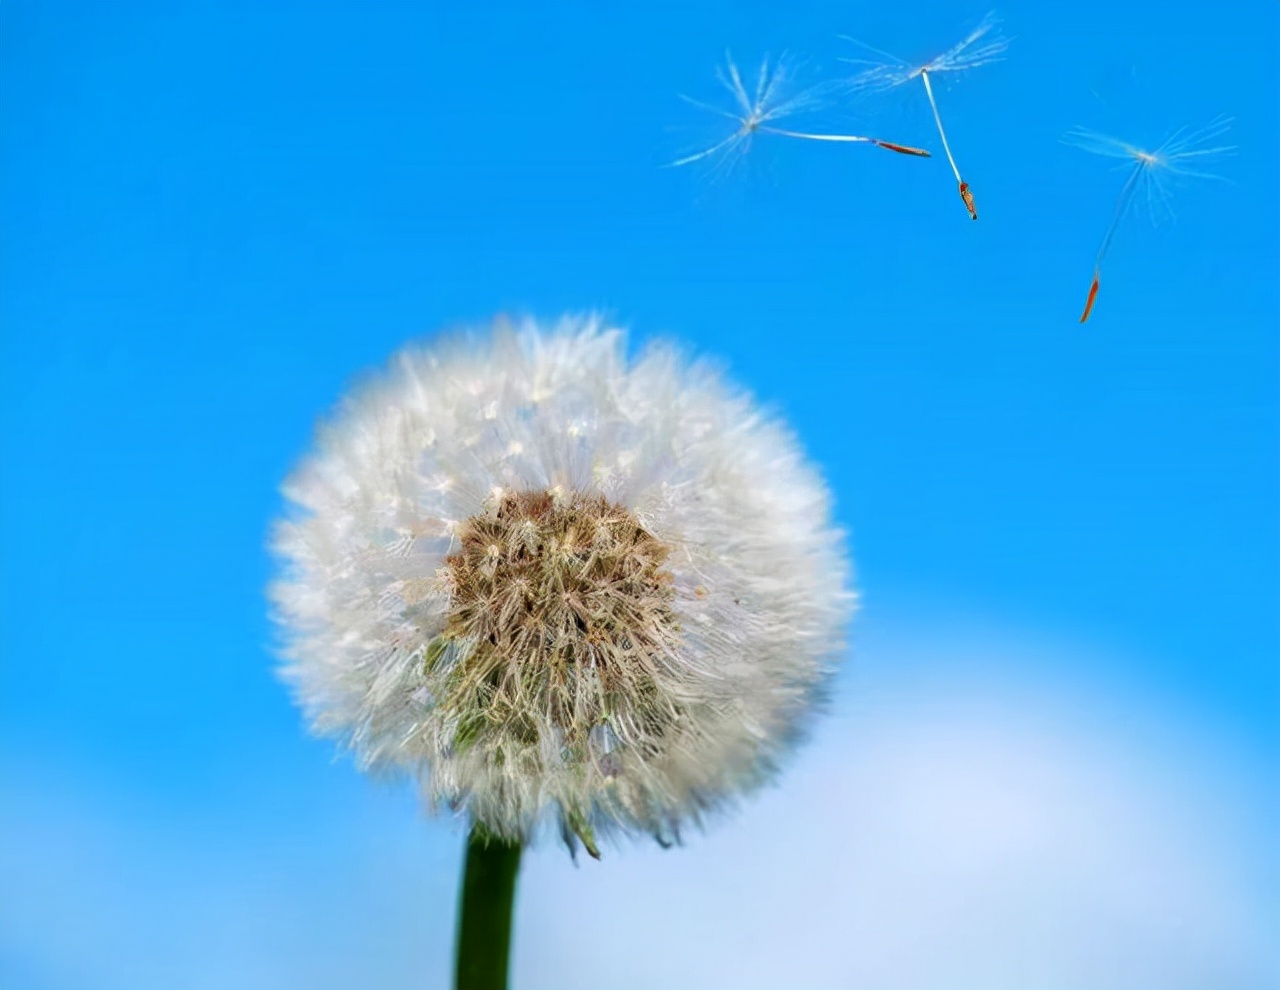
top-left (516, 640), bottom-right (1280, 990)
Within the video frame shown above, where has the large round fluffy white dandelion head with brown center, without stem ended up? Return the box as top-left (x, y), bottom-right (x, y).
top-left (271, 319), bottom-right (852, 852)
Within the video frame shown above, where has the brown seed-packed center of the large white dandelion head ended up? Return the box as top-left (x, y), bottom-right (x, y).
top-left (429, 492), bottom-right (680, 772)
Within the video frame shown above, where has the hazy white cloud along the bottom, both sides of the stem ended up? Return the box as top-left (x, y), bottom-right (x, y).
top-left (0, 622), bottom-right (1280, 990)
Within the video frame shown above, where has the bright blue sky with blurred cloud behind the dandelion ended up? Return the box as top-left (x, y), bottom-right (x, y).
top-left (0, 3), bottom-right (1280, 990)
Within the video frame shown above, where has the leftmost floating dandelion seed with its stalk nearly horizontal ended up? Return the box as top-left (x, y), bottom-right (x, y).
top-left (668, 55), bottom-right (929, 168)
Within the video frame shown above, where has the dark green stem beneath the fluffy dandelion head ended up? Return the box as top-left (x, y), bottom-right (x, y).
top-left (453, 825), bottom-right (520, 990)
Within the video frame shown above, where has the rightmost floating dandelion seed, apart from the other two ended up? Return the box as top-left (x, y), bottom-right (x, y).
top-left (1064, 117), bottom-right (1235, 323)
